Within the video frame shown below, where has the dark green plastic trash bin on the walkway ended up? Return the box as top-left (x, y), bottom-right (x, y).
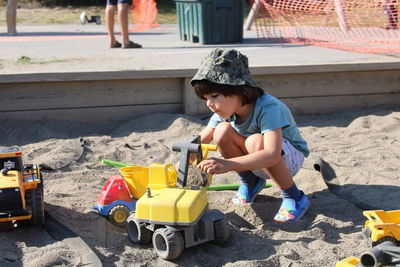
top-left (175, 0), bottom-right (244, 44)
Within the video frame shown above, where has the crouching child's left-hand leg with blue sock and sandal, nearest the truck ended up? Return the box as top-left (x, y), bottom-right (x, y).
top-left (213, 122), bottom-right (265, 204)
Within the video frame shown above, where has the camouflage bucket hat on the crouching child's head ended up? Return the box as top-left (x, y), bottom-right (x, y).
top-left (190, 48), bottom-right (259, 87)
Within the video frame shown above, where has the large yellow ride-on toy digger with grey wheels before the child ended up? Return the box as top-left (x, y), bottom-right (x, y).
top-left (127, 136), bottom-right (230, 260)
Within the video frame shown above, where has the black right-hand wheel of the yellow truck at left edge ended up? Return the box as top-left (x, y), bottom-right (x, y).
top-left (25, 183), bottom-right (44, 226)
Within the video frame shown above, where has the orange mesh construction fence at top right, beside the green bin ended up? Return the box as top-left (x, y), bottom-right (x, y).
top-left (250, 0), bottom-right (400, 55)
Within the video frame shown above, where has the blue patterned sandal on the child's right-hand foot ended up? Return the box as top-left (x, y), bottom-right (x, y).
top-left (274, 192), bottom-right (310, 222)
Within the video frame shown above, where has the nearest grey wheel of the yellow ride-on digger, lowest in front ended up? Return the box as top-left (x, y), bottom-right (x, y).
top-left (153, 228), bottom-right (185, 260)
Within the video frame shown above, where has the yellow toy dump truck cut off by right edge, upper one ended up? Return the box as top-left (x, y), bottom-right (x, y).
top-left (363, 210), bottom-right (400, 246)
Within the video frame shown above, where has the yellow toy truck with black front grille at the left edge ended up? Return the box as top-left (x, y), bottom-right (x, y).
top-left (0, 147), bottom-right (44, 226)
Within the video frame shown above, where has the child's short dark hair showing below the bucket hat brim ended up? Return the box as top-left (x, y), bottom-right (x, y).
top-left (192, 80), bottom-right (264, 106)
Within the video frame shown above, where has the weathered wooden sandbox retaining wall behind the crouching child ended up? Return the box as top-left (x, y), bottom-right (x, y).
top-left (0, 63), bottom-right (400, 121)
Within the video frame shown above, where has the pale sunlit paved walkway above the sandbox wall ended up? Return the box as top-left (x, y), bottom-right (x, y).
top-left (0, 24), bottom-right (400, 75)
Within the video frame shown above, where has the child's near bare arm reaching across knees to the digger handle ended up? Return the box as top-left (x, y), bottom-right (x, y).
top-left (198, 128), bottom-right (282, 173)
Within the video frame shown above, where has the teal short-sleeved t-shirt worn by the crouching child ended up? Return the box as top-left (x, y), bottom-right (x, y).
top-left (207, 93), bottom-right (310, 157)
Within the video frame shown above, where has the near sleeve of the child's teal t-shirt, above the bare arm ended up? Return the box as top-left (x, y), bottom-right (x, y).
top-left (258, 104), bottom-right (290, 134)
